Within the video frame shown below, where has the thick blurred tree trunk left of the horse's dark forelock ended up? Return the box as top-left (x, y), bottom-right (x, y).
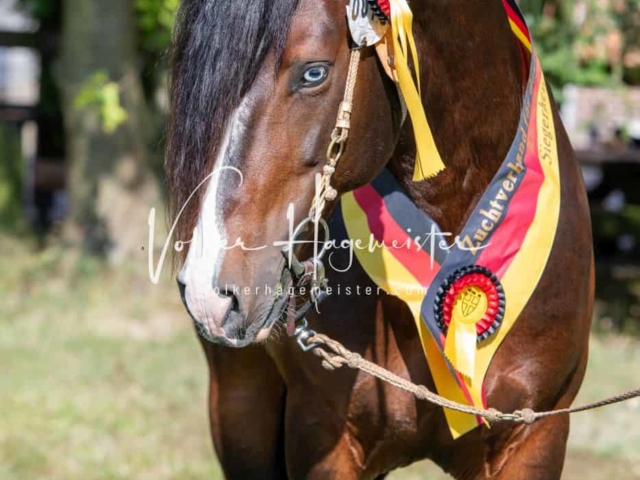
top-left (57, 0), bottom-right (160, 261)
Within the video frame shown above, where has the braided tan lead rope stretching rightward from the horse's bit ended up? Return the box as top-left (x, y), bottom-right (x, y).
top-left (308, 334), bottom-right (640, 425)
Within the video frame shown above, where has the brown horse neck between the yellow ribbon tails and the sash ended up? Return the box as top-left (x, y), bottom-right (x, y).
top-left (389, 0), bottom-right (525, 234)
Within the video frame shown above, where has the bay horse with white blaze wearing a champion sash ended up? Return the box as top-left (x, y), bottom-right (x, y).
top-left (166, 0), bottom-right (594, 480)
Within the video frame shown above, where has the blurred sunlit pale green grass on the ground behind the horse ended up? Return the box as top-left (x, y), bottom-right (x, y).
top-left (0, 237), bottom-right (640, 480)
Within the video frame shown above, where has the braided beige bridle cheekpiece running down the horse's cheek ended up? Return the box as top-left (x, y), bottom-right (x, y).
top-left (309, 49), bottom-right (361, 222)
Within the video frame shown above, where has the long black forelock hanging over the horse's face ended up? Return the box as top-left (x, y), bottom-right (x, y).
top-left (165, 0), bottom-right (299, 260)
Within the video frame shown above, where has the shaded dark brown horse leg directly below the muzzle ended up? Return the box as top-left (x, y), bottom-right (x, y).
top-left (203, 342), bottom-right (287, 480)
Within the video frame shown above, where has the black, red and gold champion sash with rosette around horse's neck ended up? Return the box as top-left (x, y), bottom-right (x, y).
top-left (341, 0), bottom-right (560, 438)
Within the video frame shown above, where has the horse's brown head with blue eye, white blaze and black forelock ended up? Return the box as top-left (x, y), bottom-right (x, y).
top-left (166, 0), bottom-right (402, 347)
